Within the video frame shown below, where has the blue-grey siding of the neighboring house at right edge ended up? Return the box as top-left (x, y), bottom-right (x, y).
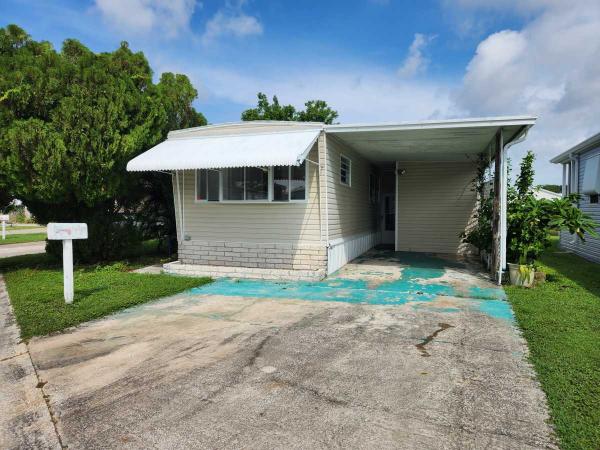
top-left (560, 148), bottom-right (600, 263)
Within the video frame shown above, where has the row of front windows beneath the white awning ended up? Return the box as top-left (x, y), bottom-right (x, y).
top-left (196, 162), bottom-right (306, 202)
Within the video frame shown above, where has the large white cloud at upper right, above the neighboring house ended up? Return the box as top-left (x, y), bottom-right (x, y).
top-left (454, 0), bottom-right (600, 182)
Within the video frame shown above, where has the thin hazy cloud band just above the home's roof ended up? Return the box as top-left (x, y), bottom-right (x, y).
top-left (152, 60), bottom-right (459, 123)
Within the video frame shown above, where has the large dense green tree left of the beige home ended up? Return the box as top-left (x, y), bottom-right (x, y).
top-left (0, 25), bottom-right (206, 259)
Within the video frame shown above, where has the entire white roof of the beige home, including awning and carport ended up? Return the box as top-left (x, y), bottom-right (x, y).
top-left (127, 116), bottom-right (535, 171)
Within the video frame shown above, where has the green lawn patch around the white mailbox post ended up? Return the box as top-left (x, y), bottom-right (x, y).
top-left (0, 244), bottom-right (210, 339)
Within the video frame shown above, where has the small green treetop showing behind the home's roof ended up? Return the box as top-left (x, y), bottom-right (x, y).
top-left (242, 92), bottom-right (338, 124)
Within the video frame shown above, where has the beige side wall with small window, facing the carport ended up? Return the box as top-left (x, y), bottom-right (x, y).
top-left (326, 135), bottom-right (377, 240)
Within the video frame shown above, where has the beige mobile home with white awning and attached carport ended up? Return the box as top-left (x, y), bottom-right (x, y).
top-left (127, 117), bottom-right (535, 279)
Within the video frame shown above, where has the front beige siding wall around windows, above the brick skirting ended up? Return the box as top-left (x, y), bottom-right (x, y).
top-left (174, 143), bottom-right (321, 245)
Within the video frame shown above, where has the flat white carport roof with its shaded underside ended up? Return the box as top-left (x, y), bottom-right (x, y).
top-left (325, 116), bottom-right (536, 162)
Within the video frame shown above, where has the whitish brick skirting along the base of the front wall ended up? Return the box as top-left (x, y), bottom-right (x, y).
top-left (178, 240), bottom-right (327, 279)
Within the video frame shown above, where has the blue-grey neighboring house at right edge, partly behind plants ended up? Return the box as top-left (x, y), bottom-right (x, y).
top-left (551, 133), bottom-right (600, 262)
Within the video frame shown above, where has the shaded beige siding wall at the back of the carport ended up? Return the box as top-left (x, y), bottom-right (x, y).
top-left (396, 161), bottom-right (476, 253)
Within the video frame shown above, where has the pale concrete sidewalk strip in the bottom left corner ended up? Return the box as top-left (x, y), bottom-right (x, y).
top-left (0, 275), bottom-right (61, 449)
